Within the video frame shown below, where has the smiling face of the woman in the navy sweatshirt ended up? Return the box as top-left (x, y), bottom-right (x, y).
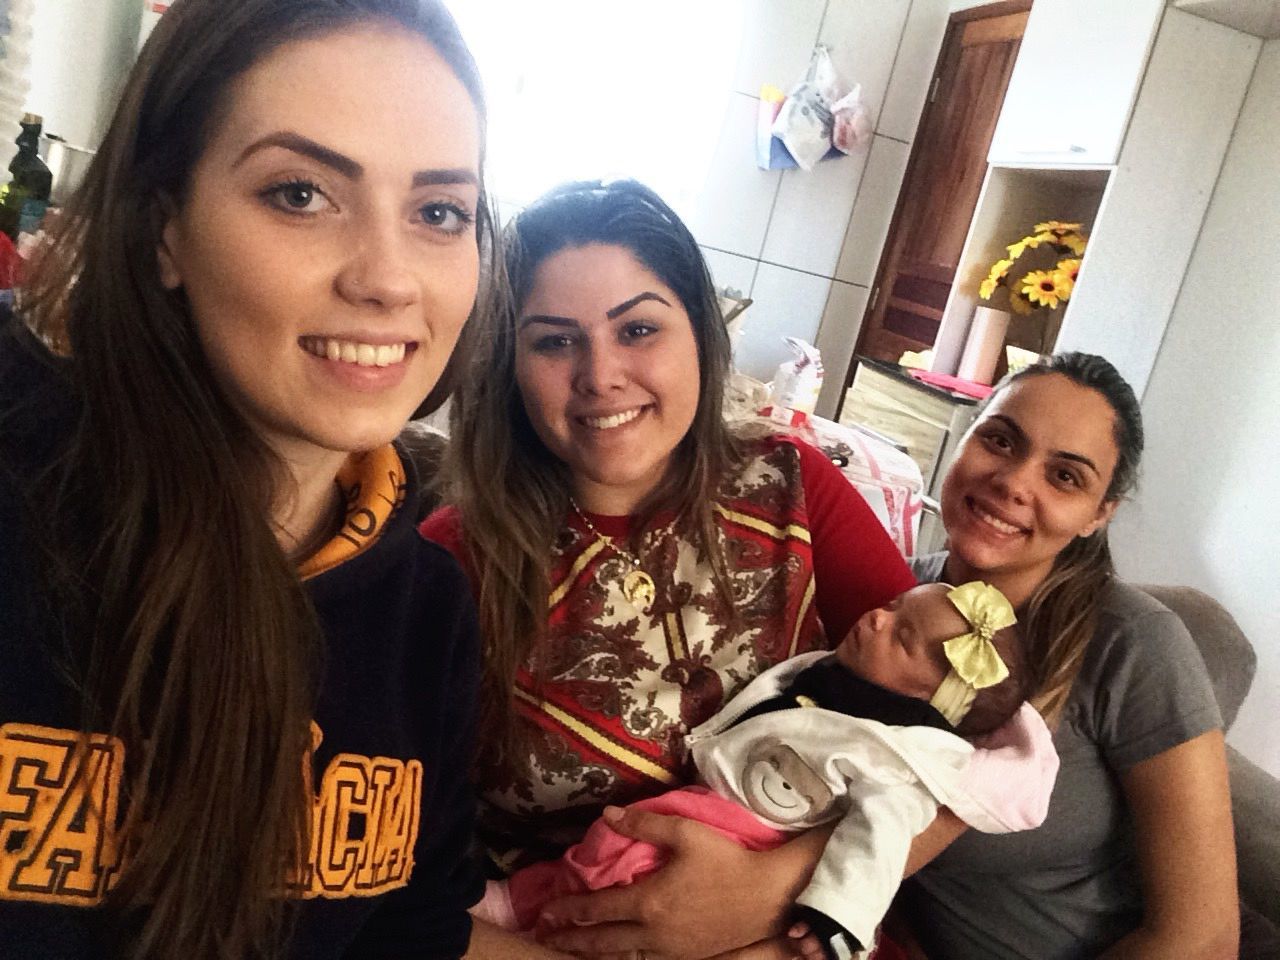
top-left (159, 24), bottom-right (480, 470)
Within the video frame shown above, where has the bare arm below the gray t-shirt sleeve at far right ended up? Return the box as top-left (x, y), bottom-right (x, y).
top-left (1103, 730), bottom-right (1240, 960)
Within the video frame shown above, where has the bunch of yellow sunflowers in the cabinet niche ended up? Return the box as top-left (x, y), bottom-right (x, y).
top-left (978, 220), bottom-right (1088, 337)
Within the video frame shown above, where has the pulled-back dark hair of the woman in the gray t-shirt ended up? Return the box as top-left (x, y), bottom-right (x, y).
top-left (972, 353), bottom-right (1143, 724)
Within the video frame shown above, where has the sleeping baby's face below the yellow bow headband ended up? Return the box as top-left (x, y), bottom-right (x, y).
top-left (836, 584), bottom-right (970, 700)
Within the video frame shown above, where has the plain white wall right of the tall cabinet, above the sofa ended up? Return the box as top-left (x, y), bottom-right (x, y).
top-left (1114, 40), bottom-right (1280, 776)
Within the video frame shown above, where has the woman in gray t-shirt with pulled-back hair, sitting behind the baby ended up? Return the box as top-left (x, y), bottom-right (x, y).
top-left (902, 353), bottom-right (1239, 960)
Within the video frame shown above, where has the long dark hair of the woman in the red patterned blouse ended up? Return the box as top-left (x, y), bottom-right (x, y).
top-left (445, 180), bottom-right (740, 764)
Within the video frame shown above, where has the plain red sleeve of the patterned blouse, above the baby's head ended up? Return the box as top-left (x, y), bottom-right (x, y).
top-left (794, 440), bottom-right (915, 645)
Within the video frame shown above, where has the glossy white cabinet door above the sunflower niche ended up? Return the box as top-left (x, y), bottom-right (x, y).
top-left (988, 0), bottom-right (1165, 166)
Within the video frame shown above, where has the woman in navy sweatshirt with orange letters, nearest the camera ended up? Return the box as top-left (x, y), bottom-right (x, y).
top-left (0, 0), bottom-right (492, 960)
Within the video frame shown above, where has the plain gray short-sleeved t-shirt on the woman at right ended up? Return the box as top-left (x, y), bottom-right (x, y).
top-left (902, 554), bottom-right (1222, 960)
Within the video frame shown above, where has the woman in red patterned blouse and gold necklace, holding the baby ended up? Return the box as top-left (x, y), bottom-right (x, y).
top-left (422, 180), bottom-right (1059, 957)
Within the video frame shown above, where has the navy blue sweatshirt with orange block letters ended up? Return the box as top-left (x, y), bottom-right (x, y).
top-left (0, 321), bottom-right (483, 960)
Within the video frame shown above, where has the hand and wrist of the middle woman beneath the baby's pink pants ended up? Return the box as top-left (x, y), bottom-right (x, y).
top-left (532, 808), bottom-right (831, 960)
